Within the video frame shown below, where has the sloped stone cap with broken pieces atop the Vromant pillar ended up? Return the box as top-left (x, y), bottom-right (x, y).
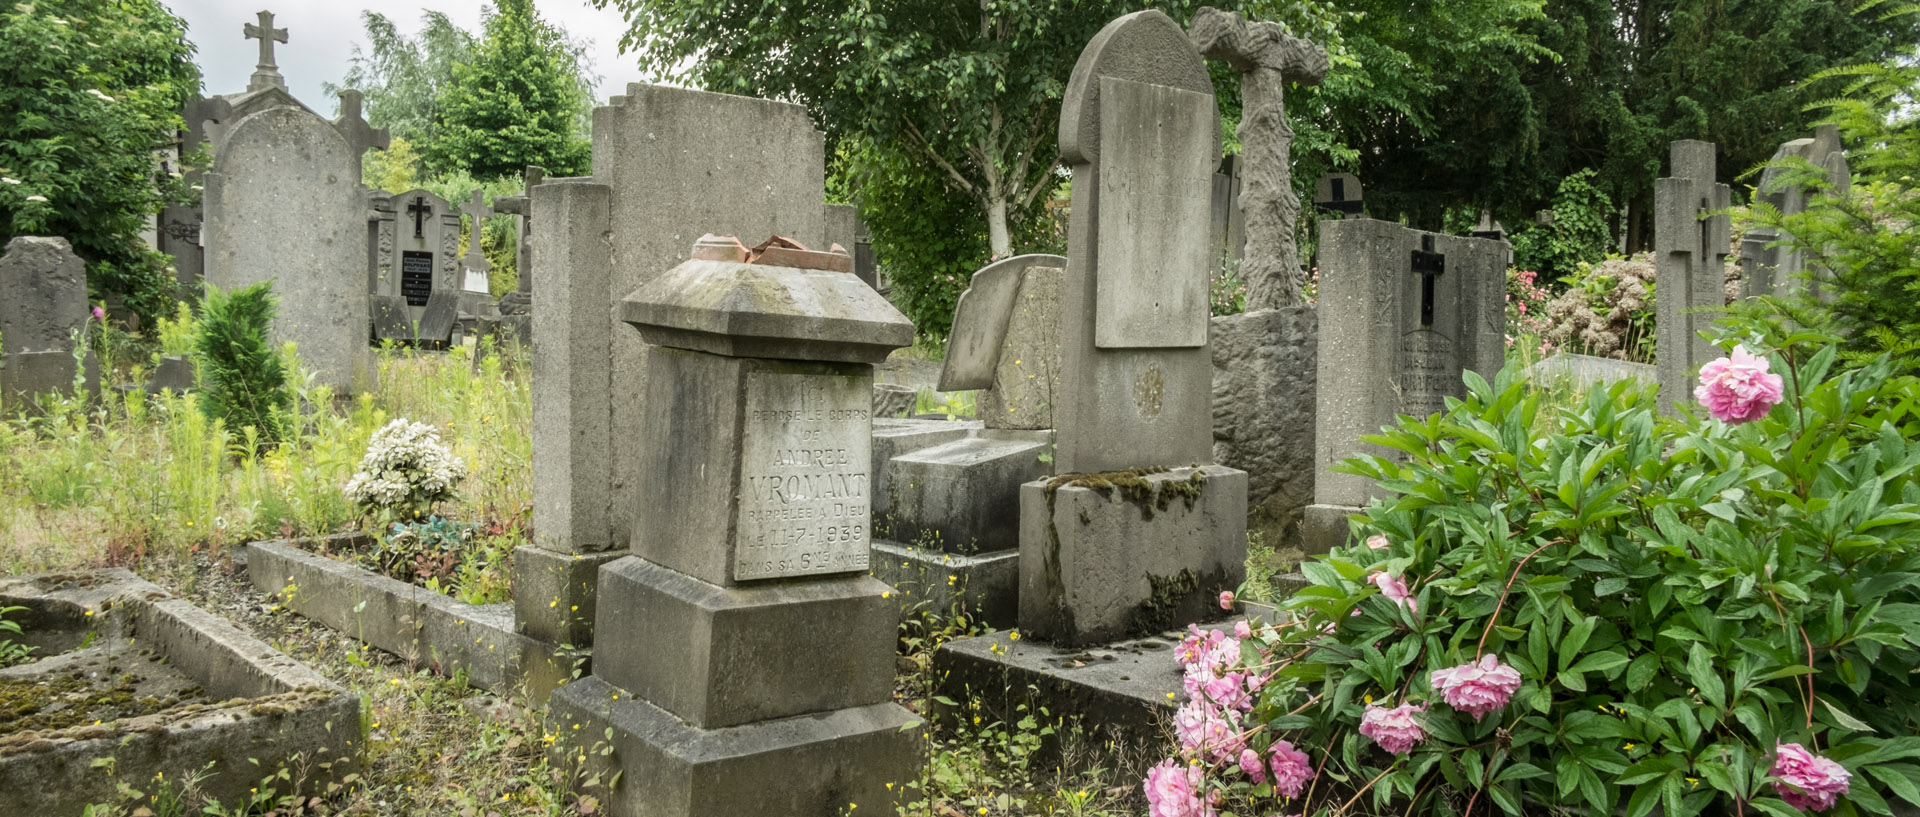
top-left (620, 234), bottom-right (914, 362)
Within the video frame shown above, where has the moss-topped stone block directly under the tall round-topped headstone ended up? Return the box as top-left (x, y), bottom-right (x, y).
top-left (1020, 466), bottom-right (1246, 644)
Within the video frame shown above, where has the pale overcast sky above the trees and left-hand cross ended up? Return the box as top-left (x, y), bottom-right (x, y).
top-left (174, 0), bottom-right (668, 117)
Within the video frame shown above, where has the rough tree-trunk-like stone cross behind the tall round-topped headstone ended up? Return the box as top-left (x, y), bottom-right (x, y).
top-left (1188, 6), bottom-right (1329, 311)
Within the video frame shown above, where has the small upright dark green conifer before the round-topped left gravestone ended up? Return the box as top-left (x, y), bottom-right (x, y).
top-left (194, 282), bottom-right (294, 445)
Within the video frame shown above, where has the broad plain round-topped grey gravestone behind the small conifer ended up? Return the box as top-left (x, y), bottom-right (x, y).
top-left (204, 105), bottom-right (374, 395)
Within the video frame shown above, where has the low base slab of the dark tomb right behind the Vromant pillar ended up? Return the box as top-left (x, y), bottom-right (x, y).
top-left (872, 541), bottom-right (1020, 627)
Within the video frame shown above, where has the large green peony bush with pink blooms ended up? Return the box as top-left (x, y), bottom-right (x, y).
top-left (1146, 324), bottom-right (1920, 817)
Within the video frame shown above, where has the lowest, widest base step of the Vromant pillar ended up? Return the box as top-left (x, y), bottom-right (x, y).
top-left (549, 677), bottom-right (922, 817)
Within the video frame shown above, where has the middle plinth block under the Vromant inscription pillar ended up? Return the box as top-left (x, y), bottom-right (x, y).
top-left (593, 556), bottom-right (900, 729)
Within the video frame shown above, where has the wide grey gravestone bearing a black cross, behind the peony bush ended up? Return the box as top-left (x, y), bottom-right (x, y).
top-left (1304, 219), bottom-right (1509, 552)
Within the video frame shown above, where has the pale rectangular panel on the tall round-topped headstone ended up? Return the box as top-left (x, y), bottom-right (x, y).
top-left (1094, 77), bottom-right (1219, 349)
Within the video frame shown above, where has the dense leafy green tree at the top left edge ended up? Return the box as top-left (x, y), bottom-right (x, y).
top-left (0, 0), bottom-right (200, 326)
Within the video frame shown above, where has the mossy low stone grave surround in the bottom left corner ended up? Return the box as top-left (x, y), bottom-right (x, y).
top-left (0, 570), bottom-right (361, 815)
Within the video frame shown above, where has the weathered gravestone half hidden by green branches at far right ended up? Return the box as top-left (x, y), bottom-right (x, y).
top-left (1740, 125), bottom-right (1853, 297)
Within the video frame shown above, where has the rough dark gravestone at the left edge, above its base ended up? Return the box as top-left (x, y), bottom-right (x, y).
top-left (0, 236), bottom-right (90, 355)
